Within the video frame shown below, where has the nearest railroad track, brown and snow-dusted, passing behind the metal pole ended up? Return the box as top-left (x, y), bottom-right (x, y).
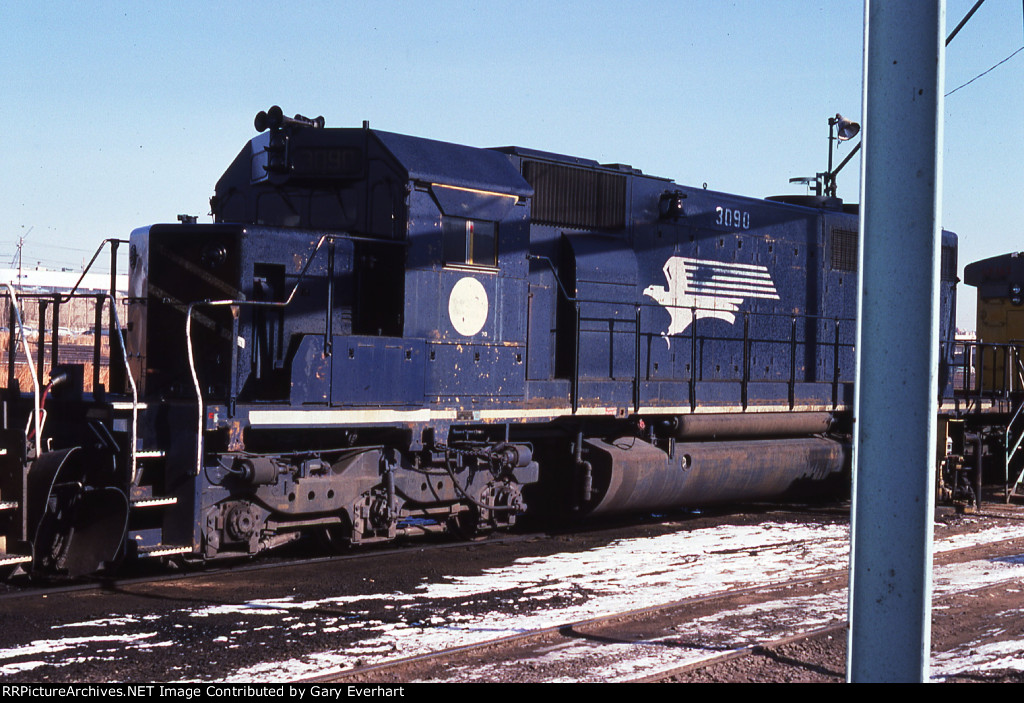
top-left (308, 537), bottom-right (1024, 684)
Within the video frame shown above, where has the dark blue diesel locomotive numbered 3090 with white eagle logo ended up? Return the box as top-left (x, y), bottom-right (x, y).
top-left (0, 107), bottom-right (956, 575)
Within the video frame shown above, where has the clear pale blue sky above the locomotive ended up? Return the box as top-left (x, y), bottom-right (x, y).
top-left (0, 0), bottom-right (1024, 326)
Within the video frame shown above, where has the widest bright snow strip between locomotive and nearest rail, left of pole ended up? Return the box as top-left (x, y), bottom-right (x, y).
top-left (216, 524), bottom-right (848, 682)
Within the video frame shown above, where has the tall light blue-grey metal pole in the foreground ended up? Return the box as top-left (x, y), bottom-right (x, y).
top-left (847, 0), bottom-right (945, 683)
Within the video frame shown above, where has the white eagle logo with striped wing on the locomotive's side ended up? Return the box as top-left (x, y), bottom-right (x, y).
top-left (643, 256), bottom-right (778, 347)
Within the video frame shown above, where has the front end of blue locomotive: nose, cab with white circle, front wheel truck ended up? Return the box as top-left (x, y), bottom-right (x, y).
top-left (116, 116), bottom-right (537, 557)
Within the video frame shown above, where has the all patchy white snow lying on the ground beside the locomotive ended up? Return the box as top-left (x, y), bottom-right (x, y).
top-left (0, 524), bottom-right (1024, 682)
